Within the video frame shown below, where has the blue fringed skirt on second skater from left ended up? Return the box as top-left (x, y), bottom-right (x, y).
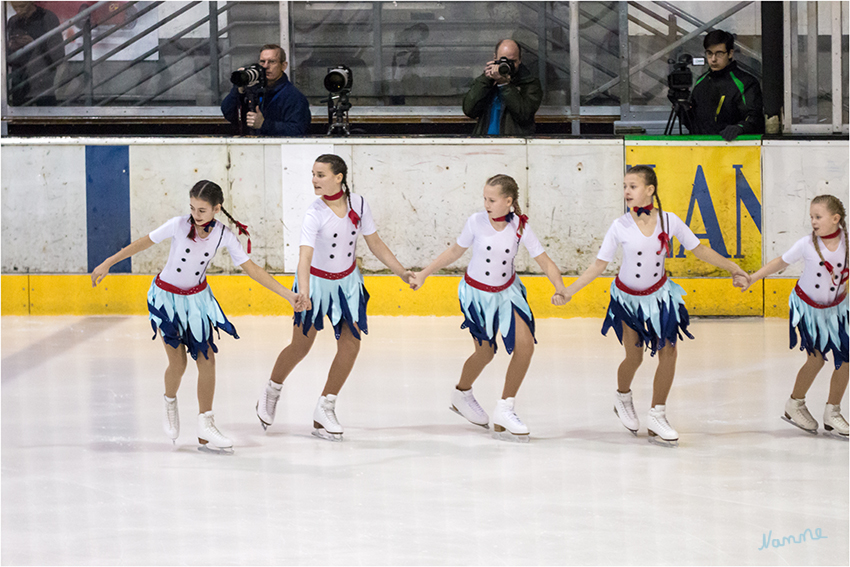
top-left (292, 267), bottom-right (369, 340)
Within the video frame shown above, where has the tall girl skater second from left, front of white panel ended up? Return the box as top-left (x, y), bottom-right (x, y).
top-left (256, 154), bottom-right (410, 441)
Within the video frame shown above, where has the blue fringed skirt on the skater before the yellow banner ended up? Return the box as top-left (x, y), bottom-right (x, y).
top-left (602, 279), bottom-right (694, 356)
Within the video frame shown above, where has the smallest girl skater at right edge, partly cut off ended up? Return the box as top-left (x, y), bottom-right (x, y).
top-left (747, 195), bottom-right (848, 441)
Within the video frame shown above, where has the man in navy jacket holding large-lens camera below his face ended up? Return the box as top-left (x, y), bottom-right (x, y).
top-left (221, 44), bottom-right (312, 136)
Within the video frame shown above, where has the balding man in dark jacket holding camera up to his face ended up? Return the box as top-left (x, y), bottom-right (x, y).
top-left (463, 39), bottom-right (543, 136)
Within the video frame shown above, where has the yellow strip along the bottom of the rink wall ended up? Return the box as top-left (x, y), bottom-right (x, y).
top-left (0, 274), bottom-right (760, 318)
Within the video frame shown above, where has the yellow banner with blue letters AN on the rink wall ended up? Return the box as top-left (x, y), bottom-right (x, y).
top-left (626, 142), bottom-right (762, 277)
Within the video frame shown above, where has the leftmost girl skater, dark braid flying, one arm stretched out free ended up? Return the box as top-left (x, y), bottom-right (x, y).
top-left (91, 181), bottom-right (298, 453)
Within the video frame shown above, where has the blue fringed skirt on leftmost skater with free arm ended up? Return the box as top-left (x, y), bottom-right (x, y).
top-left (148, 280), bottom-right (239, 360)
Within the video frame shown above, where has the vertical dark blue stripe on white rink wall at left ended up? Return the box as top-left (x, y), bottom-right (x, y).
top-left (86, 146), bottom-right (131, 273)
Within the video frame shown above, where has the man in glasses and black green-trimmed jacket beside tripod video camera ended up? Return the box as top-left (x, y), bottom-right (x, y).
top-left (687, 30), bottom-right (764, 141)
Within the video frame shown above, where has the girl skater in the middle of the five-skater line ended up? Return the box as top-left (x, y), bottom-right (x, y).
top-left (410, 175), bottom-right (566, 442)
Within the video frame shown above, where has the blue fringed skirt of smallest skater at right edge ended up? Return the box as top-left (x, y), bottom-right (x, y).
top-left (788, 289), bottom-right (848, 370)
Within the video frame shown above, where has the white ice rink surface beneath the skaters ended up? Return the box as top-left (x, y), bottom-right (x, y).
top-left (0, 317), bottom-right (850, 565)
